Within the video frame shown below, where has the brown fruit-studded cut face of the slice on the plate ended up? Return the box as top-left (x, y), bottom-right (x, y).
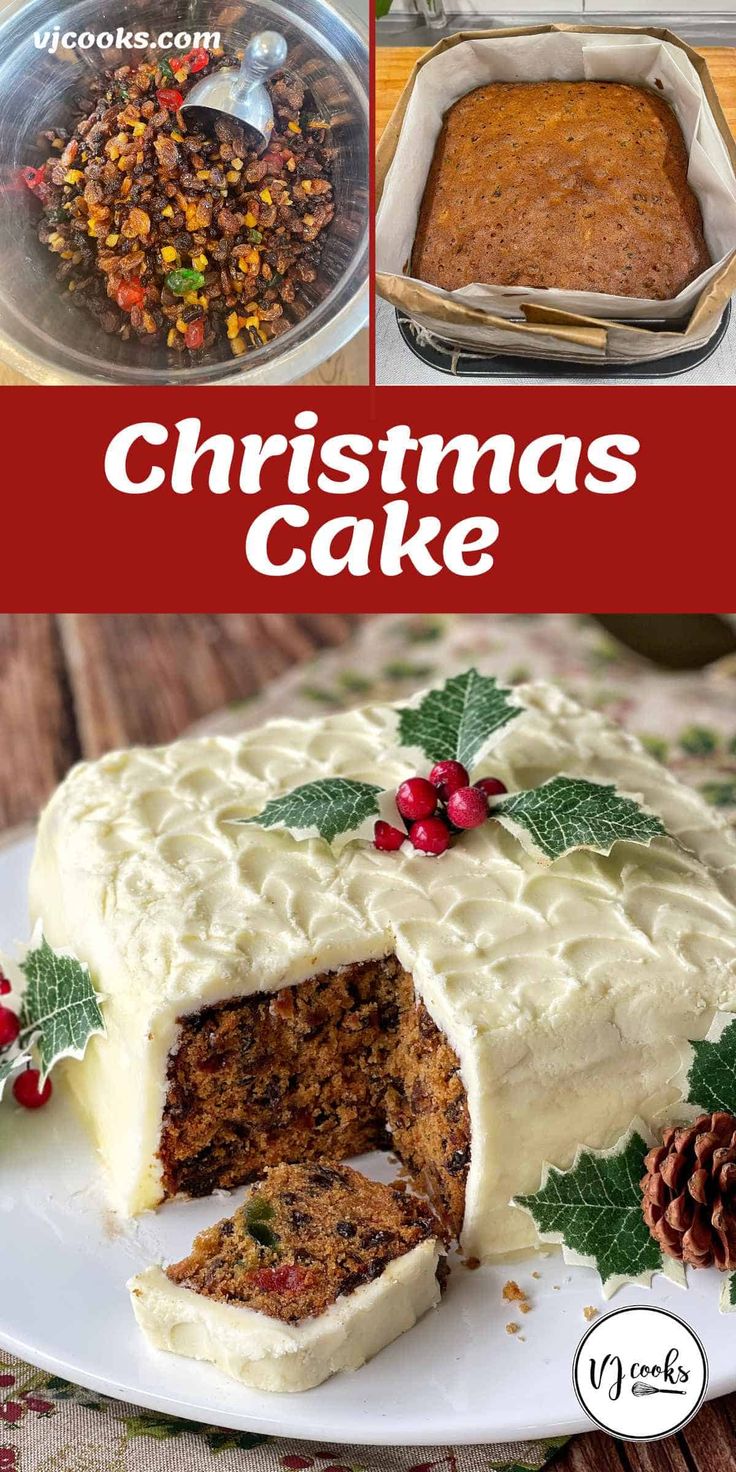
top-left (166, 1163), bottom-right (445, 1323)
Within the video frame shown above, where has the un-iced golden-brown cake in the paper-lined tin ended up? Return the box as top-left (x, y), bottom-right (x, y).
top-left (411, 81), bottom-right (711, 300)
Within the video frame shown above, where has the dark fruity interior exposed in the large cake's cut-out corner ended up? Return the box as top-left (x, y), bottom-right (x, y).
top-left (159, 957), bottom-right (470, 1236)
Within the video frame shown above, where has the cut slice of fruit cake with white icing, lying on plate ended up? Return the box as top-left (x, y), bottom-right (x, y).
top-left (128, 1163), bottom-right (445, 1391)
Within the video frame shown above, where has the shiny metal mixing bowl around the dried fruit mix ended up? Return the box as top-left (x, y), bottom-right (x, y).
top-left (0, 0), bottom-right (369, 386)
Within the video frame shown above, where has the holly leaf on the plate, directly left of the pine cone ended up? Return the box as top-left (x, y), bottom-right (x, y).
top-left (514, 1129), bottom-right (662, 1297)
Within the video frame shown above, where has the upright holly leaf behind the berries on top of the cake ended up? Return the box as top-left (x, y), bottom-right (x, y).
top-left (399, 670), bottom-right (521, 770)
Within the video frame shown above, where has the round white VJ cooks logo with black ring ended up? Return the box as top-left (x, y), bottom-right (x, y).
top-left (573, 1304), bottom-right (708, 1441)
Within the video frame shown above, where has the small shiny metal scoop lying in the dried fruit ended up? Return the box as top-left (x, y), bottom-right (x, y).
top-left (181, 31), bottom-right (287, 153)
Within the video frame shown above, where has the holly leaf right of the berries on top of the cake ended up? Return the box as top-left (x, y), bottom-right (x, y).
top-left (492, 777), bottom-right (665, 860)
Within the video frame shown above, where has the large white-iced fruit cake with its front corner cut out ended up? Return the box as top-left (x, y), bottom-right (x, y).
top-left (31, 683), bottom-right (736, 1262)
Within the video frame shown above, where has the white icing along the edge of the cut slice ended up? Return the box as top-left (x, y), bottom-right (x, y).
top-left (128, 1239), bottom-right (440, 1391)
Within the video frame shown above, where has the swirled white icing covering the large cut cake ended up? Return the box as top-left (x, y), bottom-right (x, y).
top-left (31, 683), bottom-right (736, 1259)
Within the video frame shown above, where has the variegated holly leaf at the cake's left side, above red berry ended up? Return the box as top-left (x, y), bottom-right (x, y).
top-left (19, 935), bottom-right (105, 1080)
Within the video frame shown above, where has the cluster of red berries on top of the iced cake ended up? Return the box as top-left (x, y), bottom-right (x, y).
top-left (374, 761), bottom-right (506, 854)
